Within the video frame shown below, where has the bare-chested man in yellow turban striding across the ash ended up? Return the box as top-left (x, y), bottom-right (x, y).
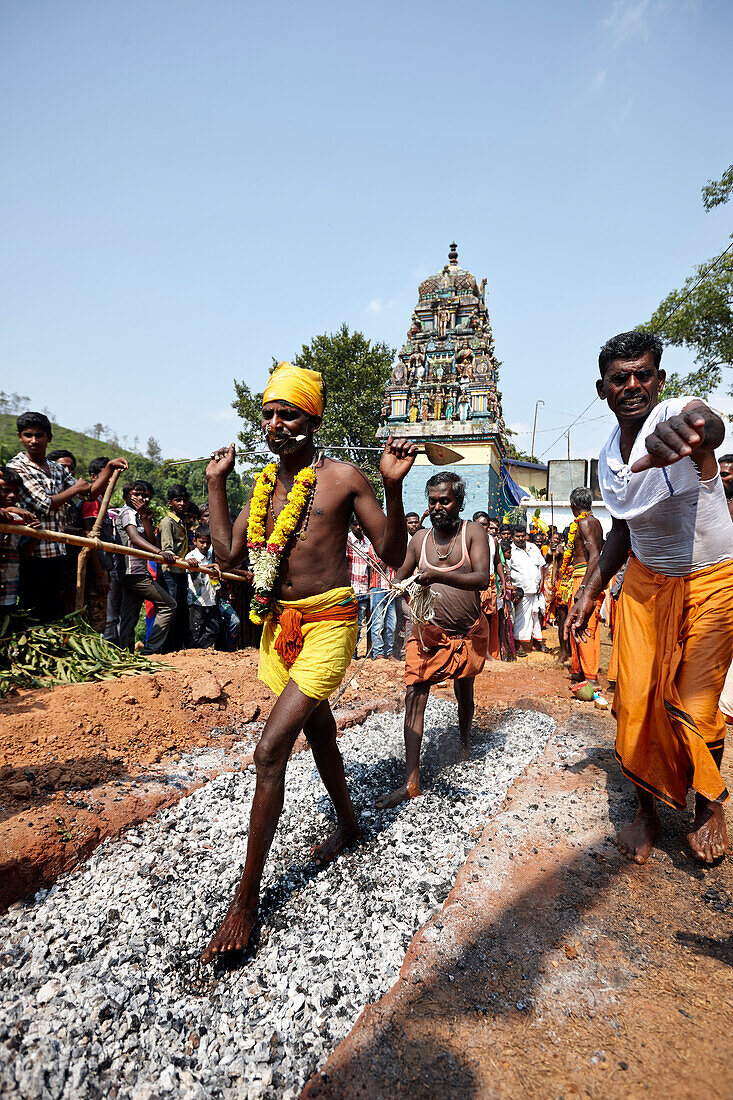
top-left (201, 363), bottom-right (416, 964)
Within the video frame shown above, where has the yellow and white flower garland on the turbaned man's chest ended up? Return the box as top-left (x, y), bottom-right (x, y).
top-left (247, 462), bottom-right (316, 625)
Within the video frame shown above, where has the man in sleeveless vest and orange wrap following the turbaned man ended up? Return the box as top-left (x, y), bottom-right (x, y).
top-left (376, 472), bottom-right (491, 810)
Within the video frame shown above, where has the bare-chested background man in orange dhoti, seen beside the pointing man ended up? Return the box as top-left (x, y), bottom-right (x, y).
top-left (561, 488), bottom-right (603, 688)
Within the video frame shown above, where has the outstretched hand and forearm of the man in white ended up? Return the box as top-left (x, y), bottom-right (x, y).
top-left (632, 397), bottom-right (725, 481)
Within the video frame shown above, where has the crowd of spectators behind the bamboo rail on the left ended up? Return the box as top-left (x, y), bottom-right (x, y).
top-left (0, 413), bottom-right (241, 653)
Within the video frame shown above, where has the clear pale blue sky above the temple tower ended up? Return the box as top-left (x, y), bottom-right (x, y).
top-left (0, 0), bottom-right (733, 458)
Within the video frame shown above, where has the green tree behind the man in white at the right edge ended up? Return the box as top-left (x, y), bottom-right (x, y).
top-left (639, 165), bottom-right (733, 397)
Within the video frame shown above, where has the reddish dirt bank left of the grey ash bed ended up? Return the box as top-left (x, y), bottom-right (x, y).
top-left (0, 650), bottom-right (403, 911)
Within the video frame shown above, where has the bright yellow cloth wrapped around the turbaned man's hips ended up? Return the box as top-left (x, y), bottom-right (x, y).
top-left (258, 587), bottom-right (358, 702)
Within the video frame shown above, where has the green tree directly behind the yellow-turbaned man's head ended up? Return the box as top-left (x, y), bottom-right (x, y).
top-left (232, 325), bottom-right (395, 491)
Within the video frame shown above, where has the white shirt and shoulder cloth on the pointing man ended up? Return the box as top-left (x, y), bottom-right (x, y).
top-left (598, 396), bottom-right (733, 576)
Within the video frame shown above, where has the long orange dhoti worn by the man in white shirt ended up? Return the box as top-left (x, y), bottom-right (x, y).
top-left (613, 558), bottom-right (733, 810)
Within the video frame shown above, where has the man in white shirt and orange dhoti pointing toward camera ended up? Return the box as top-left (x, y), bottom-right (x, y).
top-left (566, 332), bottom-right (733, 864)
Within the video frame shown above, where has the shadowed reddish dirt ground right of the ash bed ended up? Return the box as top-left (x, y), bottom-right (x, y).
top-left (304, 648), bottom-right (733, 1100)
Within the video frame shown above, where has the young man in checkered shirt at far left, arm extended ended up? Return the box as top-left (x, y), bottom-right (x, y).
top-left (8, 413), bottom-right (128, 623)
